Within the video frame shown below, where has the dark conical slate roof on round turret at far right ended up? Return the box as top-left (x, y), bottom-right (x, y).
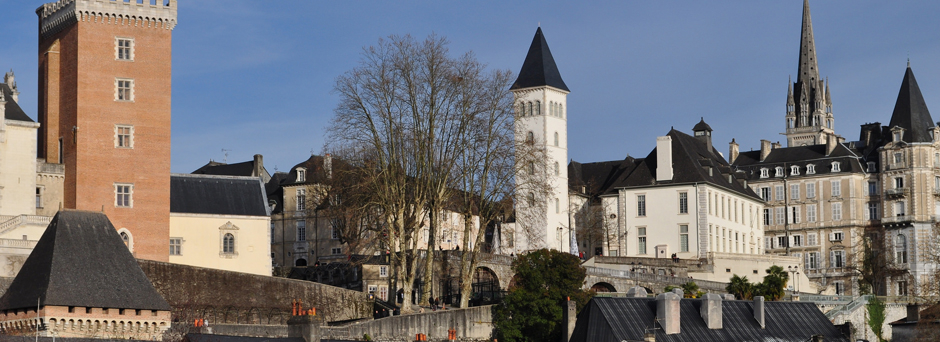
top-left (888, 65), bottom-right (936, 143)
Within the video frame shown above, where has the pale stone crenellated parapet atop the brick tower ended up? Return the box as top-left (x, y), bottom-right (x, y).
top-left (36, 0), bottom-right (177, 38)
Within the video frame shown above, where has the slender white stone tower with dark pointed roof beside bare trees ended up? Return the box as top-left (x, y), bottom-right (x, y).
top-left (510, 28), bottom-right (574, 253)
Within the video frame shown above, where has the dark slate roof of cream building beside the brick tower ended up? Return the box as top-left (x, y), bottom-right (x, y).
top-left (170, 174), bottom-right (270, 216)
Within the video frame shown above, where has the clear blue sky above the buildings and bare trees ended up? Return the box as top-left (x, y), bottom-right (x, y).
top-left (0, 0), bottom-right (940, 173)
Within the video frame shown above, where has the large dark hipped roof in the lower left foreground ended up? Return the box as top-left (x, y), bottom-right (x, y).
top-left (0, 210), bottom-right (170, 310)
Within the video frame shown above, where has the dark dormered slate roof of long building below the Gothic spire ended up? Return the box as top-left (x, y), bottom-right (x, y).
top-left (734, 143), bottom-right (874, 180)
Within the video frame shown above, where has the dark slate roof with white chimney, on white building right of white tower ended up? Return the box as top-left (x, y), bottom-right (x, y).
top-left (607, 129), bottom-right (759, 199)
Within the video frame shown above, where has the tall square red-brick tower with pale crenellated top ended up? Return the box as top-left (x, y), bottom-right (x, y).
top-left (36, 0), bottom-right (177, 261)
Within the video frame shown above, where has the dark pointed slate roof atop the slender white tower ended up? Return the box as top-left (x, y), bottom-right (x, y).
top-left (509, 27), bottom-right (570, 91)
